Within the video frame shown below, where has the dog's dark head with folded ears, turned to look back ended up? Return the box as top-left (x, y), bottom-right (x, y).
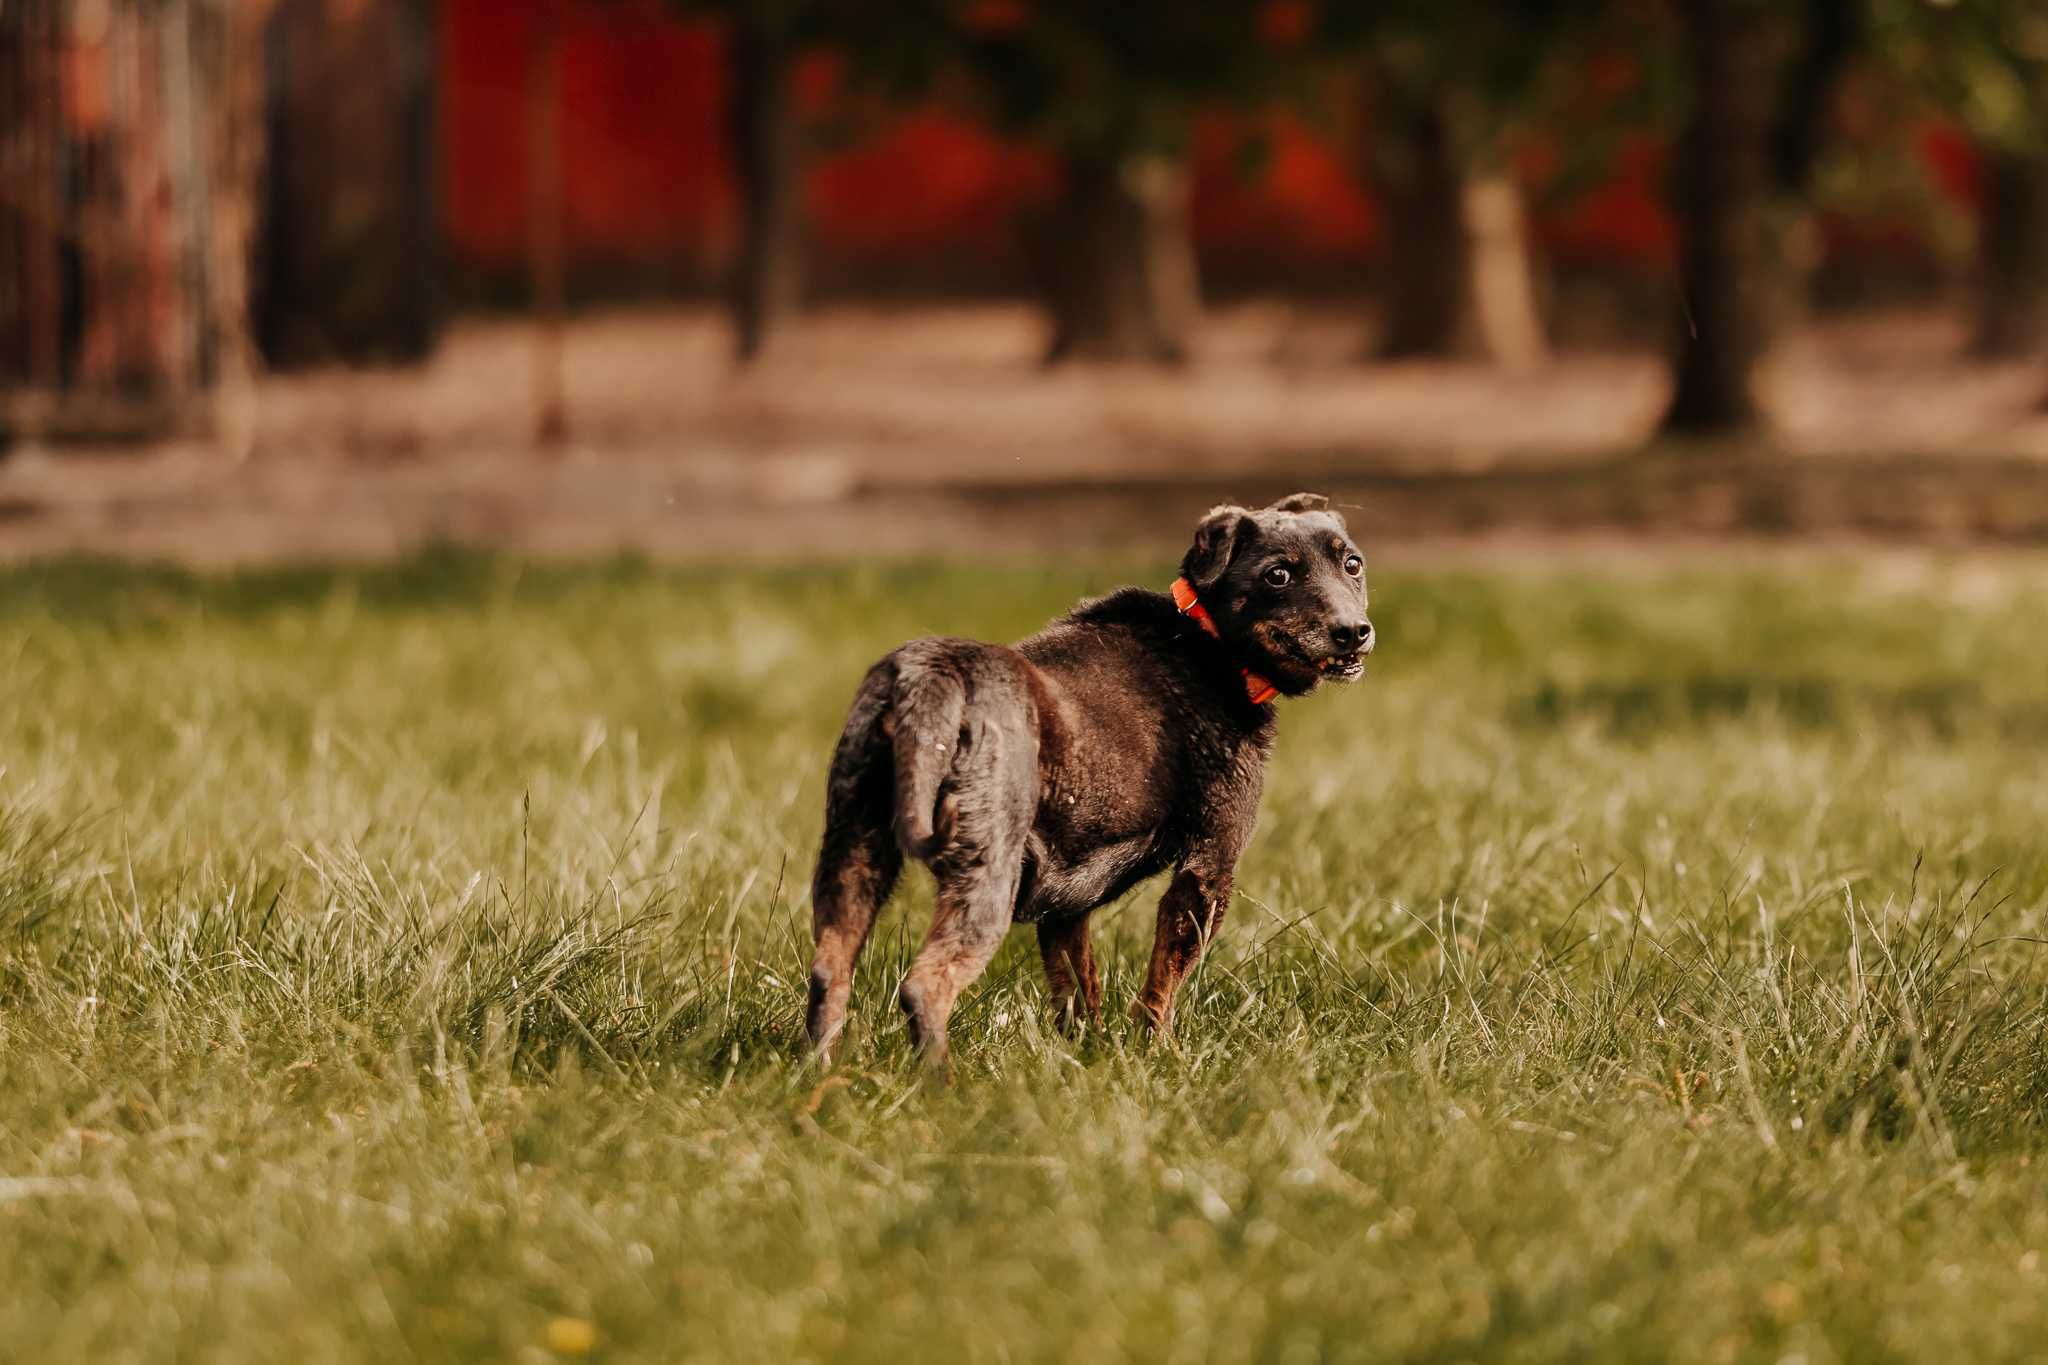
top-left (1180, 493), bottom-right (1374, 696)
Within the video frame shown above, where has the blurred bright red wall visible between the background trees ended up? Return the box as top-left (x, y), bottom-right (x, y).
top-left (440, 0), bottom-right (1970, 290)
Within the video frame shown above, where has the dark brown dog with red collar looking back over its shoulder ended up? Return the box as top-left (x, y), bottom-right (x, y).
top-left (807, 493), bottom-right (1374, 1070)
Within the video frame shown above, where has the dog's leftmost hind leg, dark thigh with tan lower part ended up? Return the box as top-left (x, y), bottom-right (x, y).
top-left (805, 667), bottom-right (903, 1062)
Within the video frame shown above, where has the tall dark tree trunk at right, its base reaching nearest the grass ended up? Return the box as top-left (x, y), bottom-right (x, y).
top-left (1663, 0), bottom-right (1772, 436)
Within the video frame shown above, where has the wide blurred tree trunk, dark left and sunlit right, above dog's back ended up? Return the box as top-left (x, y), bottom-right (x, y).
top-left (1030, 153), bottom-right (1202, 364)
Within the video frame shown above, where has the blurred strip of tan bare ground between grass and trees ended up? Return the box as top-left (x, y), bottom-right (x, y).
top-left (0, 305), bottom-right (2048, 563)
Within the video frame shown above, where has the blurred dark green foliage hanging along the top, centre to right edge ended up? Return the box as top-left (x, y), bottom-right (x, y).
top-left (655, 0), bottom-right (2048, 300)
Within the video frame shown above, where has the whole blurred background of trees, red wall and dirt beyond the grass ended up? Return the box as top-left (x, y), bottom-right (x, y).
top-left (0, 0), bottom-right (2048, 561)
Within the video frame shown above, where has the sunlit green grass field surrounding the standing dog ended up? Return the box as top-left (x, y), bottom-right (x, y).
top-left (0, 557), bottom-right (2048, 1365)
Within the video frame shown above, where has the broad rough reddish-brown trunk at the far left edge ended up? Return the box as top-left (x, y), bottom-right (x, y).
top-left (0, 0), bottom-right (254, 440)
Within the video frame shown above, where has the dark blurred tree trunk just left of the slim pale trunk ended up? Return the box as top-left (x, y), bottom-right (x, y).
top-left (1368, 98), bottom-right (1477, 360)
